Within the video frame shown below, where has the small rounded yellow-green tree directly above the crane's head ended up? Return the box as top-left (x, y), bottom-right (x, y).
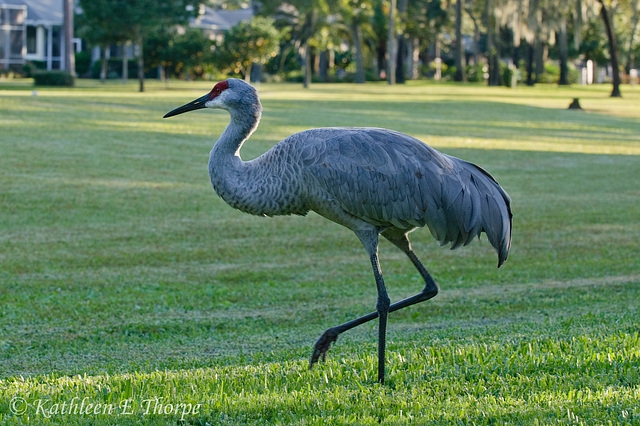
top-left (214, 16), bottom-right (280, 82)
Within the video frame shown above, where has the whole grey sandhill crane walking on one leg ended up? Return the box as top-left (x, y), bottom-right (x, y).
top-left (164, 78), bottom-right (511, 383)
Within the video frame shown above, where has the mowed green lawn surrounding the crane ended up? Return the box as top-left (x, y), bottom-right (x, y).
top-left (0, 81), bottom-right (640, 425)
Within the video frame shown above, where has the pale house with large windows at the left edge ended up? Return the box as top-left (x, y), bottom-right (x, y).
top-left (0, 0), bottom-right (80, 70)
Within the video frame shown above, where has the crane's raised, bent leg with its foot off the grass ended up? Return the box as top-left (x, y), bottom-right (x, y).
top-left (309, 231), bottom-right (438, 382)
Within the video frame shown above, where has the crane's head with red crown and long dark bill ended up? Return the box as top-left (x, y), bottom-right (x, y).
top-left (163, 78), bottom-right (262, 118)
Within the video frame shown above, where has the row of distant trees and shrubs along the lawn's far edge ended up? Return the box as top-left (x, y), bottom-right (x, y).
top-left (76, 0), bottom-right (640, 96)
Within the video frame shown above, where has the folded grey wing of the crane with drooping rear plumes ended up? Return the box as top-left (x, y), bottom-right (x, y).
top-left (298, 128), bottom-right (511, 265)
